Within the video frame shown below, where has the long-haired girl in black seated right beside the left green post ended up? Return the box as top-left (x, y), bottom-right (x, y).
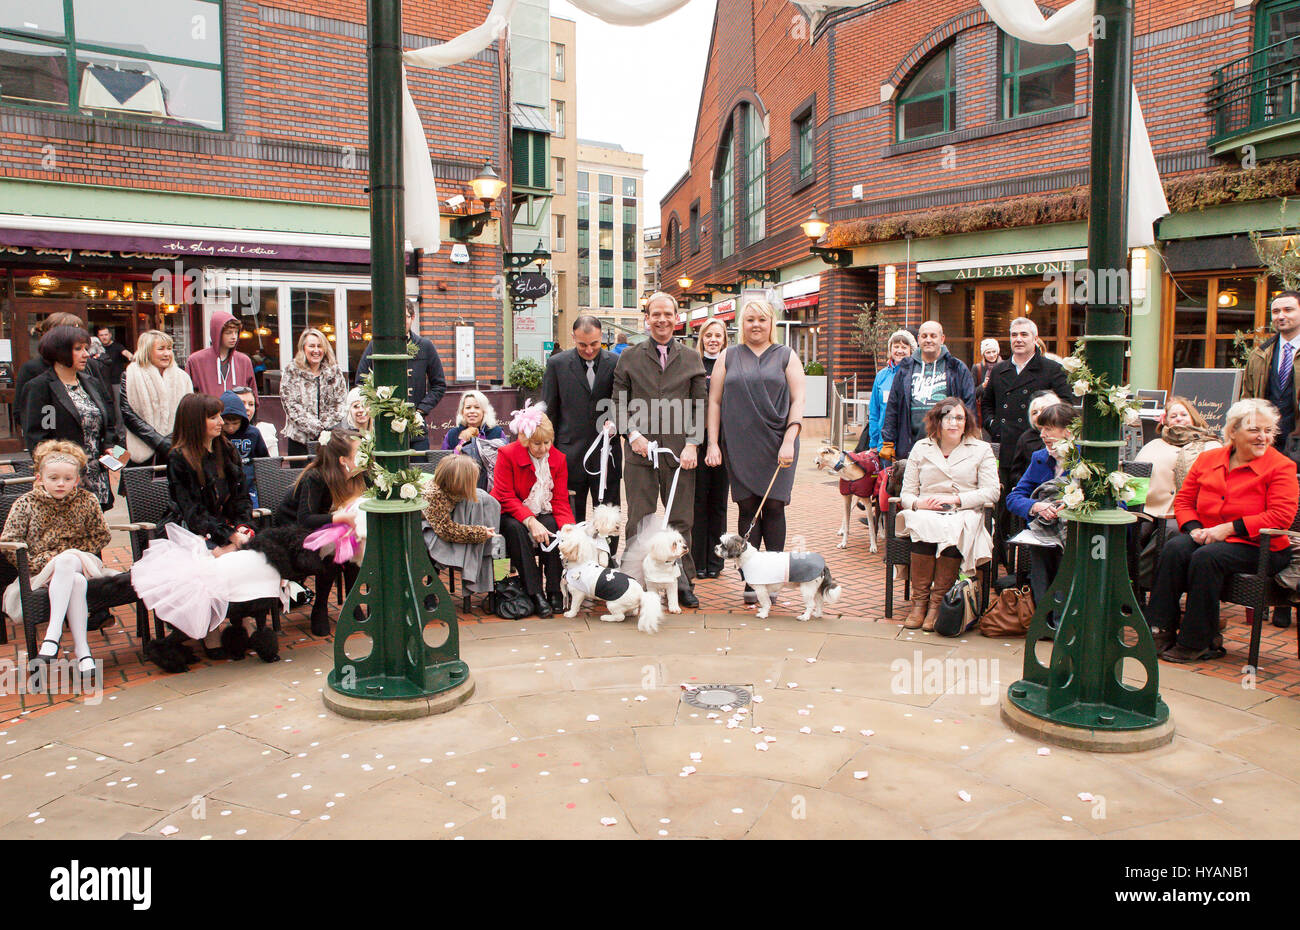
top-left (268, 429), bottom-right (365, 636)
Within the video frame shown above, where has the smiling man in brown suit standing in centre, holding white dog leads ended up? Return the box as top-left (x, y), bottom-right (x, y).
top-left (612, 291), bottom-right (707, 607)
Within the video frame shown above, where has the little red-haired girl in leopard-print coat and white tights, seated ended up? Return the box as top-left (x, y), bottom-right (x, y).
top-left (0, 440), bottom-right (117, 675)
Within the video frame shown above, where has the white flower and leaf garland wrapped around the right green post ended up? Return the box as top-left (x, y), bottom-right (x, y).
top-left (1053, 342), bottom-right (1141, 514)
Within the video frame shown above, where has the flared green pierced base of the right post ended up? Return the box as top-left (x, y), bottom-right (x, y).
top-left (1002, 511), bottom-right (1174, 752)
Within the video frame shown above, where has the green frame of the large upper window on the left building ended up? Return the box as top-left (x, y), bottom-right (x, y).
top-left (0, 0), bottom-right (230, 134)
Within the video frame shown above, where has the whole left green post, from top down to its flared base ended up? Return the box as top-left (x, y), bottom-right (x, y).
top-left (320, 0), bottom-right (473, 719)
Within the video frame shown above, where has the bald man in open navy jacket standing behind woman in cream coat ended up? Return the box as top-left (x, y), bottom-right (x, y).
top-left (880, 320), bottom-right (975, 459)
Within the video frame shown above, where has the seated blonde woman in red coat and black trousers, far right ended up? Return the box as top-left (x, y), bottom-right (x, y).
top-left (1147, 398), bottom-right (1297, 662)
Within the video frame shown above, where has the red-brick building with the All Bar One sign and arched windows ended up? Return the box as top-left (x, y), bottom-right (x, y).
top-left (660, 0), bottom-right (1300, 405)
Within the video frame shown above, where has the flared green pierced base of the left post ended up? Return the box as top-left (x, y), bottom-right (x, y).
top-left (321, 501), bottom-right (475, 721)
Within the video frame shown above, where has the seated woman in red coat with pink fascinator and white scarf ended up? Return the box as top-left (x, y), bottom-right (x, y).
top-left (491, 403), bottom-right (573, 618)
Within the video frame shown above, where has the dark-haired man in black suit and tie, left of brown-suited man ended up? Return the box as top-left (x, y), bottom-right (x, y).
top-left (542, 316), bottom-right (623, 551)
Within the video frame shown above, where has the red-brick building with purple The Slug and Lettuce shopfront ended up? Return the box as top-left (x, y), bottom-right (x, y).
top-left (0, 0), bottom-right (506, 447)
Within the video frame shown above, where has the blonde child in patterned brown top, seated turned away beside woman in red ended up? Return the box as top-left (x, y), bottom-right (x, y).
top-left (424, 455), bottom-right (501, 593)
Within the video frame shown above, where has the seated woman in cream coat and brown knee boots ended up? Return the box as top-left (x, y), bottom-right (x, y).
top-left (898, 397), bottom-right (1001, 631)
